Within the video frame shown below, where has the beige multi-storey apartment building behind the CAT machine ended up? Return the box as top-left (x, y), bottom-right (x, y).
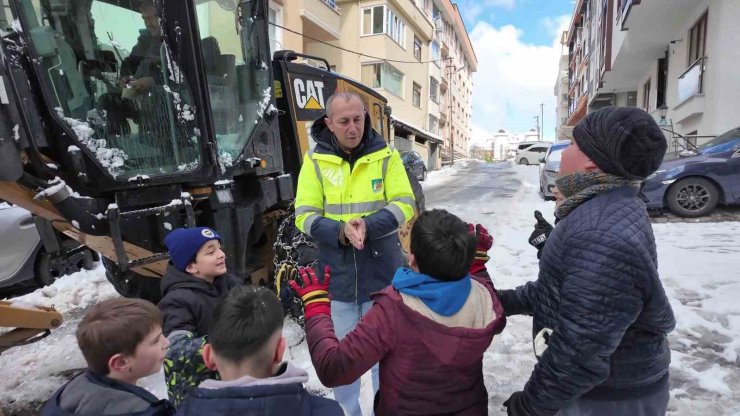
top-left (269, 0), bottom-right (477, 170)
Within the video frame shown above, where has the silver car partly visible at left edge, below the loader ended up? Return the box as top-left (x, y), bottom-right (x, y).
top-left (0, 202), bottom-right (99, 288)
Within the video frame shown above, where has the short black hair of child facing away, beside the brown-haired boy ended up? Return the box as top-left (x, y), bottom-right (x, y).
top-left (208, 285), bottom-right (283, 363)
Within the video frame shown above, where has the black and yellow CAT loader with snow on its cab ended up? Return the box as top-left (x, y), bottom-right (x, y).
top-left (0, 0), bottom-right (420, 348)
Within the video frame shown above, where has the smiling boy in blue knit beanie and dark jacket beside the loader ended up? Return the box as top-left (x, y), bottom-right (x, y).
top-left (158, 227), bottom-right (243, 337)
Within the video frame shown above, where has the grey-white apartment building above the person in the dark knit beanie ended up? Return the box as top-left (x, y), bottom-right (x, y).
top-left (569, 0), bottom-right (740, 149)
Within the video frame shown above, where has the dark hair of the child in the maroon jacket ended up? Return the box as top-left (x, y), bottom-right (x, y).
top-left (411, 209), bottom-right (475, 281)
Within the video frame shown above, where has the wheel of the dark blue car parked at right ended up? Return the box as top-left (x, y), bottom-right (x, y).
top-left (666, 178), bottom-right (719, 218)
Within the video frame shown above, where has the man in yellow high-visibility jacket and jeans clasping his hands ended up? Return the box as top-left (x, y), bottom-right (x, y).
top-left (295, 92), bottom-right (416, 415)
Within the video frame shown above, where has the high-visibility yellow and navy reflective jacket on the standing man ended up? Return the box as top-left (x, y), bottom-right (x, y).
top-left (295, 114), bottom-right (416, 303)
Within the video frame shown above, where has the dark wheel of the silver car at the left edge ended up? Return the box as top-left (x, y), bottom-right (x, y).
top-left (34, 240), bottom-right (95, 287)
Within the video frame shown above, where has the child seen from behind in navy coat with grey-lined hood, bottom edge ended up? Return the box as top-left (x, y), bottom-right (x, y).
top-left (177, 285), bottom-right (344, 416)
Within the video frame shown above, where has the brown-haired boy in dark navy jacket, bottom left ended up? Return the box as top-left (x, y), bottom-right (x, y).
top-left (41, 298), bottom-right (175, 416)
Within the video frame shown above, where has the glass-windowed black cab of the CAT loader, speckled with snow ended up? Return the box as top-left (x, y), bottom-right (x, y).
top-left (4, 0), bottom-right (282, 193)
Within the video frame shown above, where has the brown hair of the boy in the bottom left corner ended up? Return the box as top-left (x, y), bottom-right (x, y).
top-left (77, 298), bottom-right (162, 375)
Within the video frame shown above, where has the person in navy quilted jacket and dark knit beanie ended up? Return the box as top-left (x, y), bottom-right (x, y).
top-left (499, 107), bottom-right (675, 416)
